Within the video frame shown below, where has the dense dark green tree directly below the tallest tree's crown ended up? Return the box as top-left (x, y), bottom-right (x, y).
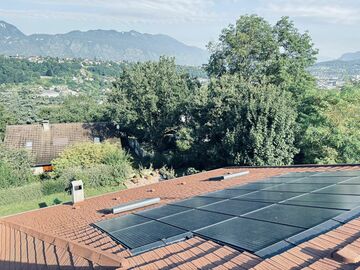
top-left (188, 75), bottom-right (297, 166)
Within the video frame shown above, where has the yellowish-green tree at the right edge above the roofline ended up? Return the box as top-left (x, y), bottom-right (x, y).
top-left (298, 86), bottom-right (360, 164)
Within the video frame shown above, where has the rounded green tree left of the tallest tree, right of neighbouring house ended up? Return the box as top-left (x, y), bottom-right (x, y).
top-left (108, 57), bottom-right (197, 151)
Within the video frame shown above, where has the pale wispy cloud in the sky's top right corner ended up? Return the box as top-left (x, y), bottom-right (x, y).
top-left (267, 0), bottom-right (360, 24)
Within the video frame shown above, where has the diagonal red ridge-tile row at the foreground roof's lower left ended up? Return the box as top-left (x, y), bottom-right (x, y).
top-left (0, 220), bottom-right (126, 269)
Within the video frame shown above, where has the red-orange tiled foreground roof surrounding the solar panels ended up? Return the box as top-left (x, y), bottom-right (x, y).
top-left (0, 163), bottom-right (360, 269)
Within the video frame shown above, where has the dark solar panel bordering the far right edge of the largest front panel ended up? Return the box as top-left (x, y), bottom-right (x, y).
top-left (245, 205), bottom-right (344, 229)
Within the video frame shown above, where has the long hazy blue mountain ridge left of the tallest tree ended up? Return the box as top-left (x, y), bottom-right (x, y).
top-left (0, 21), bottom-right (208, 66)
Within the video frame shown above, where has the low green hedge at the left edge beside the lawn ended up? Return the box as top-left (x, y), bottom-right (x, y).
top-left (0, 182), bottom-right (43, 205)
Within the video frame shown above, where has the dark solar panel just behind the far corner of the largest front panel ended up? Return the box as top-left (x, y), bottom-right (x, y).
top-left (201, 200), bottom-right (271, 216)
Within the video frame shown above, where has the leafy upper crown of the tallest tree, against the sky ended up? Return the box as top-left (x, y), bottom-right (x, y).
top-left (206, 15), bottom-right (317, 98)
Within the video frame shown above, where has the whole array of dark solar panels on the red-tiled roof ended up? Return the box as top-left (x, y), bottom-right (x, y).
top-left (95, 171), bottom-right (360, 257)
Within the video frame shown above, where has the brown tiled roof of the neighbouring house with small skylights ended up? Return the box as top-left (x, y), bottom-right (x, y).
top-left (4, 123), bottom-right (114, 165)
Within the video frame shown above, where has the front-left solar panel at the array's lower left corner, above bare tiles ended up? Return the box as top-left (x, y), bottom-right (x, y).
top-left (110, 221), bottom-right (191, 254)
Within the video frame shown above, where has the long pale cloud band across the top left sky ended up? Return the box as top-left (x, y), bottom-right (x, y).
top-left (0, 0), bottom-right (225, 24)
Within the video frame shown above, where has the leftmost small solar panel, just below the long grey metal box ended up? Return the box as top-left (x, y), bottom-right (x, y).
top-left (95, 215), bottom-right (151, 232)
